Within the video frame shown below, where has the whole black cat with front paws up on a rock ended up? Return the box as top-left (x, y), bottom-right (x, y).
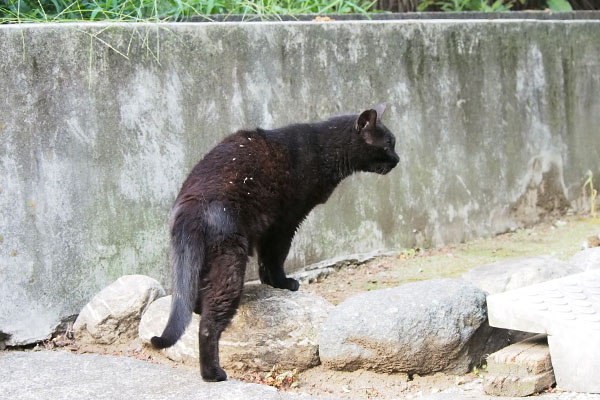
top-left (152, 104), bottom-right (399, 381)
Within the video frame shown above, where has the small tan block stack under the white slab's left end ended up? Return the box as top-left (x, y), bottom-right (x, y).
top-left (483, 335), bottom-right (554, 397)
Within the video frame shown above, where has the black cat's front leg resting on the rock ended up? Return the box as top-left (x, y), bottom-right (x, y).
top-left (258, 229), bottom-right (300, 291)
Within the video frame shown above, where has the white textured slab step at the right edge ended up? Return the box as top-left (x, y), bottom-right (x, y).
top-left (487, 270), bottom-right (600, 393)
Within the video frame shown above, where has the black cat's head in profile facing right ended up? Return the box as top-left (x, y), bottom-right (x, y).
top-left (354, 103), bottom-right (400, 175)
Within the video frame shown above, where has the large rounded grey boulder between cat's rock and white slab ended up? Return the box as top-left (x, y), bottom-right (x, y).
top-left (319, 279), bottom-right (506, 375)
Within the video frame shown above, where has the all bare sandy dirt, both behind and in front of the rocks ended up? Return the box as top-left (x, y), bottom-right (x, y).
top-left (24, 216), bottom-right (600, 400)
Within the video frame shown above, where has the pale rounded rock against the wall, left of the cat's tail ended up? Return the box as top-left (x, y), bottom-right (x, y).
top-left (73, 275), bottom-right (165, 344)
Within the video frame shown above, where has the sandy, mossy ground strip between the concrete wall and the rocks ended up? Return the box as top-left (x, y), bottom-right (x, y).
top-left (301, 217), bottom-right (600, 304)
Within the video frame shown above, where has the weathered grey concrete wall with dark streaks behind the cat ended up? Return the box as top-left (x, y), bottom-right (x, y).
top-left (0, 20), bottom-right (600, 344)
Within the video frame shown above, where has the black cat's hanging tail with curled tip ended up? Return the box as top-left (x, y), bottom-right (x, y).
top-left (150, 208), bottom-right (204, 349)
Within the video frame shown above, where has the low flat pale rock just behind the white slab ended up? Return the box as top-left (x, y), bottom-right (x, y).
top-left (463, 256), bottom-right (581, 294)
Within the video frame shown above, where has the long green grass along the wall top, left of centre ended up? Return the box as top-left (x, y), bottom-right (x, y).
top-left (0, 0), bottom-right (375, 23)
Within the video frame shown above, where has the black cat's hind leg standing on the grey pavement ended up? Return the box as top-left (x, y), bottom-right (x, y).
top-left (197, 235), bottom-right (248, 382)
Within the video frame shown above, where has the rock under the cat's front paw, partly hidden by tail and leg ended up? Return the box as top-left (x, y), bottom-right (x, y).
top-left (139, 285), bottom-right (334, 371)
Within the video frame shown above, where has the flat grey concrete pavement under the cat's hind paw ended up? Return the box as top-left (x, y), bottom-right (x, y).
top-left (0, 351), bottom-right (324, 400)
